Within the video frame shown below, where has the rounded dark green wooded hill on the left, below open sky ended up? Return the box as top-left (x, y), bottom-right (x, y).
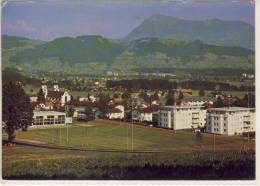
top-left (9, 36), bottom-right (125, 64)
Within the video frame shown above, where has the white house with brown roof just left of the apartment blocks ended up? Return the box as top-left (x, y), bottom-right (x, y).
top-left (132, 107), bottom-right (158, 122)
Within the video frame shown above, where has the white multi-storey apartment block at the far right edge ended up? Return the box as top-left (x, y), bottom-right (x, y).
top-left (206, 107), bottom-right (255, 136)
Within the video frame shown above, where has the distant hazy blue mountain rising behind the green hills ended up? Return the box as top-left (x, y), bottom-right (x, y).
top-left (124, 15), bottom-right (255, 50)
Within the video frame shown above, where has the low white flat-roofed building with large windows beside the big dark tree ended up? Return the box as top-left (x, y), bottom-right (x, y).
top-left (31, 111), bottom-right (70, 127)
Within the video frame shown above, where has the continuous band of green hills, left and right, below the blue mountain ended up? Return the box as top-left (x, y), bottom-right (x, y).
top-left (2, 36), bottom-right (255, 74)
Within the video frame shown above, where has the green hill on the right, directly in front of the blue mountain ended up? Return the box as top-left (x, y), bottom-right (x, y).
top-left (112, 38), bottom-right (255, 69)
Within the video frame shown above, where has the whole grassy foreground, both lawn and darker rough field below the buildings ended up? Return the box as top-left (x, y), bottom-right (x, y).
top-left (2, 120), bottom-right (255, 180)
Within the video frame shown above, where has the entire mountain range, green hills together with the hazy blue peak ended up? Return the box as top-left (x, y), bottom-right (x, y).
top-left (2, 15), bottom-right (255, 73)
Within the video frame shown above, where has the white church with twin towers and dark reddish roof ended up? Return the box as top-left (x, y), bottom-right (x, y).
top-left (42, 85), bottom-right (71, 106)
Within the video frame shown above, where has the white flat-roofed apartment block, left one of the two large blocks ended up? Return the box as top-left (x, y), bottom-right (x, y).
top-left (158, 106), bottom-right (206, 130)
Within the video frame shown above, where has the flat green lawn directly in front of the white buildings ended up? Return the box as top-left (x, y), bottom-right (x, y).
top-left (22, 121), bottom-right (244, 150)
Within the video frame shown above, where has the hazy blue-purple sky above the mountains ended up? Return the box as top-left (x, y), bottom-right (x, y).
top-left (1, 0), bottom-right (255, 41)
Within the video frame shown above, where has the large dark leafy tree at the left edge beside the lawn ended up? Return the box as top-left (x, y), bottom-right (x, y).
top-left (3, 82), bottom-right (33, 143)
